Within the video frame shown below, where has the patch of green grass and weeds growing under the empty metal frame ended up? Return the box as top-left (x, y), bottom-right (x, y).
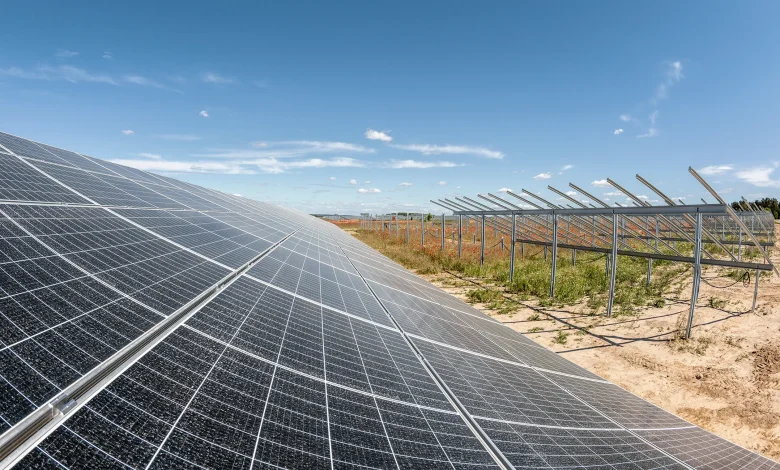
top-left (356, 226), bottom-right (691, 316)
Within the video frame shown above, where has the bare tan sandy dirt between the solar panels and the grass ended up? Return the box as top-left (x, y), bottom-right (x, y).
top-left (366, 225), bottom-right (780, 460)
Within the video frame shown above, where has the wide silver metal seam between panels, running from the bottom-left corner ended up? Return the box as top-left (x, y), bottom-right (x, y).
top-left (0, 225), bottom-right (304, 468)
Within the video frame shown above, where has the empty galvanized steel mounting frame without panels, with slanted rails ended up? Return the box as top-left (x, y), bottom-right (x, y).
top-left (360, 167), bottom-right (780, 338)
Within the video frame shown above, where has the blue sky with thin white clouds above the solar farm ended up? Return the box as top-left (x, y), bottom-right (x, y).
top-left (0, 1), bottom-right (780, 213)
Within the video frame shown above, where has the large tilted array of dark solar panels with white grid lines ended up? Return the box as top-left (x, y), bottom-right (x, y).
top-left (0, 129), bottom-right (780, 469)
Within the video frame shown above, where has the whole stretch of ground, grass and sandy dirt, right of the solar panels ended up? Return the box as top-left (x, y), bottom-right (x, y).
top-left (340, 220), bottom-right (780, 459)
